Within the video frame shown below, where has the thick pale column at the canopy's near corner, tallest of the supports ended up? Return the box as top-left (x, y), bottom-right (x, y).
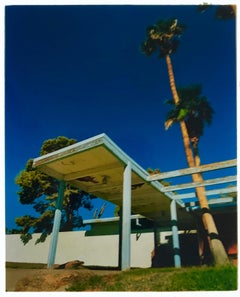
top-left (121, 162), bottom-right (132, 270)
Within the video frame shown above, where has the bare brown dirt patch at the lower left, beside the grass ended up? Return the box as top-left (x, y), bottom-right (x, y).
top-left (6, 268), bottom-right (120, 292)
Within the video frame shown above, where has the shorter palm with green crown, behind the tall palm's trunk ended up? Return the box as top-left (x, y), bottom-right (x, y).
top-left (165, 85), bottom-right (214, 166)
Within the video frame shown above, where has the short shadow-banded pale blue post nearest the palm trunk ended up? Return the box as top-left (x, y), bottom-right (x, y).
top-left (170, 200), bottom-right (181, 268)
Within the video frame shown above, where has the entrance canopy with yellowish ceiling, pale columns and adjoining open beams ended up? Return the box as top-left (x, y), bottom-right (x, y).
top-left (33, 134), bottom-right (236, 269)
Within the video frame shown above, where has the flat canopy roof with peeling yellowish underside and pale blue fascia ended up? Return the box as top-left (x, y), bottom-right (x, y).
top-left (33, 134), bottom-right (193, 226)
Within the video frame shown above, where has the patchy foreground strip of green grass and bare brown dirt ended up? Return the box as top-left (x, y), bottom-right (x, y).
top-left (6, 263), bottom-right (237, 292)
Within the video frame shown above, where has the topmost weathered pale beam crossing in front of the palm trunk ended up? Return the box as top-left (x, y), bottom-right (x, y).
top-left (147, 159), bottom-right (237, 181)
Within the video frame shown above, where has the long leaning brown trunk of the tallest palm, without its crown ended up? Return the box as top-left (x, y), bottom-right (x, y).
top-left (166, 55), bottom-right (229, 265)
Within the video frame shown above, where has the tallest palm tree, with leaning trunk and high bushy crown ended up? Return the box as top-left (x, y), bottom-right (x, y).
top-left (141, 19), bottom-right (229, 265)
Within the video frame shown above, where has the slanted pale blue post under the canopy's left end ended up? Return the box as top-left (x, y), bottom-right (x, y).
top-left (48, 181), bottom-right (65, 268)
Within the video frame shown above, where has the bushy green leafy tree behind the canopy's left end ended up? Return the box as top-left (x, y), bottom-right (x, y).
top-left (15, 136), bottom-right (95, 244)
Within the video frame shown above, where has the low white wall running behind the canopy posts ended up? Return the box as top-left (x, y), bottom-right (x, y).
top-left (6, 231), bottom-right (154, 267)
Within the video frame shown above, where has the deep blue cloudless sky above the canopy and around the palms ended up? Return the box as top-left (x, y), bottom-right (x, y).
top-left (5, 5), bottom-right (236, 228)
